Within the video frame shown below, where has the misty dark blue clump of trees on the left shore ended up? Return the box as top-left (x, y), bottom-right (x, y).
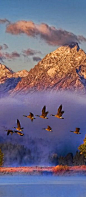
top-left (0, 143), bottom-right (39, 166)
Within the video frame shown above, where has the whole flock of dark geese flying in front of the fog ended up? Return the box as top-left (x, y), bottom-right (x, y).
top-left (5, 104), bottom-right (81, 136)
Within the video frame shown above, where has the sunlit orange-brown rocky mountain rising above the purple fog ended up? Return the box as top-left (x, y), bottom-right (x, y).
top-left (0, 43), bottom-right (86, 94)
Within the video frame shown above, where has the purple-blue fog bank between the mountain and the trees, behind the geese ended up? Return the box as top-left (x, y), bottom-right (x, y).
top-left (0, 91), bottom-right (86, 163)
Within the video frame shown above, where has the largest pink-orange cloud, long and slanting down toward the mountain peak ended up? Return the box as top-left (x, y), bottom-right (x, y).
top-left (6, 20), bottom-right (86, 46)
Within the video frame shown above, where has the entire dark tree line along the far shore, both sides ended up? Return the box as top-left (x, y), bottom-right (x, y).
top-left (0, 136), bottom-right (86, 166)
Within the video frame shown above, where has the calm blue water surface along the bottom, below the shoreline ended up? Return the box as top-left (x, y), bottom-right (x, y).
top-left (0, 175), bottom-right (86, 197)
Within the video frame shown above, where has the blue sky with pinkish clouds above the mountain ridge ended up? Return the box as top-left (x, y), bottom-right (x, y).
top-left (0, 0), bottom-right (86, 71)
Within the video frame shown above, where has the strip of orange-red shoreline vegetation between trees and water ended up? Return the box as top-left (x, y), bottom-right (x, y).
top-left (0, 165), bottom-right (86, 175)
